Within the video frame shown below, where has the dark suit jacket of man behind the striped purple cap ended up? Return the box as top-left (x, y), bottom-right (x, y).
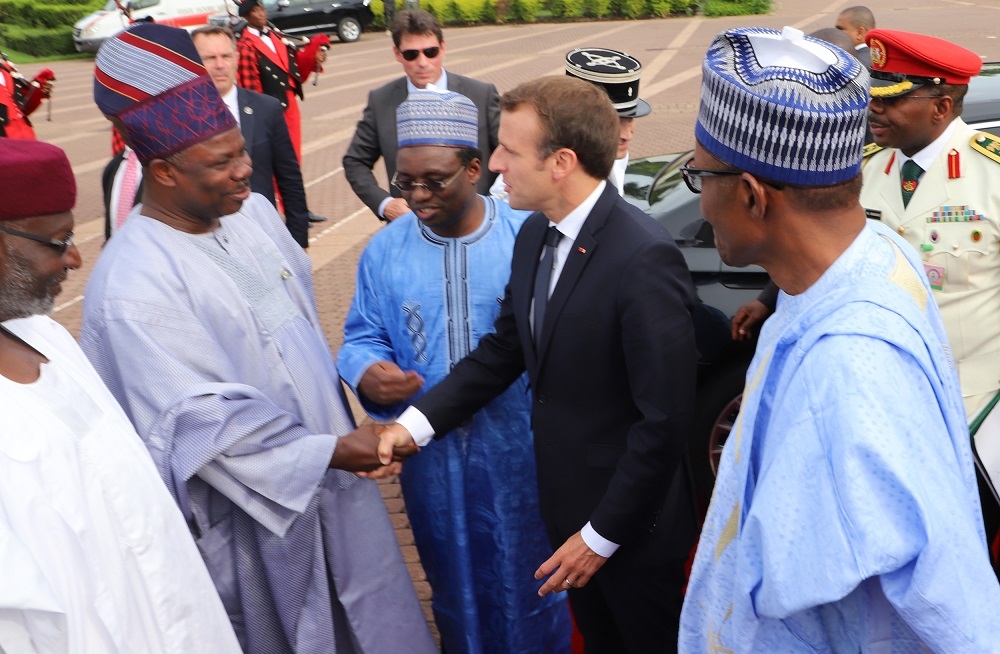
top-left (236, 87), bottom-right (309, 247)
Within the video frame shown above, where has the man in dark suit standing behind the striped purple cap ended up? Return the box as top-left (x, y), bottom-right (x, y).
top-left (191, 25), bottom-right (309, 248)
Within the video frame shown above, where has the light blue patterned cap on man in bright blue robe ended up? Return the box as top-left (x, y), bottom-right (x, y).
top-left (396, 89), bottom-right (479, 148)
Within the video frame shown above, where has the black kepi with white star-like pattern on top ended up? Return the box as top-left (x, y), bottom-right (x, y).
top-left (566, 48), bottom-right (651, 118)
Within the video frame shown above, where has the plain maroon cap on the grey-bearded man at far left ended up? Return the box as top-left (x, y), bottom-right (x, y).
top-left (0, 139), bottom-right (76, 220)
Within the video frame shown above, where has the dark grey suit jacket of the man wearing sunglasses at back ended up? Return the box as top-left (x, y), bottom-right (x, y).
top-left (343, 71), bottom-right (500, 216)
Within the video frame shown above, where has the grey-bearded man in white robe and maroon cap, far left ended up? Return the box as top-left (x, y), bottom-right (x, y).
top-left (0, 141), bottom-right (240, 654)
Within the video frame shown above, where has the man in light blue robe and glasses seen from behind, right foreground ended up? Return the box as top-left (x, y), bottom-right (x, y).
top-left (680, 27), bottom-right (1000, 654)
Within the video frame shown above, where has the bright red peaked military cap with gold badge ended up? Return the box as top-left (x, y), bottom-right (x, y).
top-left (865, 29), bottom-right (983, 98)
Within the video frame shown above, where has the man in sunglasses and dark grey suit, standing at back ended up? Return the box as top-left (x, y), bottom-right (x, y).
top-left (343, 9), bottom-right (500, 222)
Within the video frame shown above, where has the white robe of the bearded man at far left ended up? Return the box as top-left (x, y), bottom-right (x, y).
top-left (0, 316), bottom-right (240, 654)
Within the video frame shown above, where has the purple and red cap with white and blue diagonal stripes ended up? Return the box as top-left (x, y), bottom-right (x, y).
top-left (94, 23), bottom-right (237, 164)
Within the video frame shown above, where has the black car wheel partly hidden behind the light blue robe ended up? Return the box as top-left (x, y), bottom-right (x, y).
top-left (688, 366), bottom-right (746, 512)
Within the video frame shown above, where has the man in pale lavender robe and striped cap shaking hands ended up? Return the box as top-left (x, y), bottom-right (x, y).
top-left (81, 24), bottom-right (434, 654)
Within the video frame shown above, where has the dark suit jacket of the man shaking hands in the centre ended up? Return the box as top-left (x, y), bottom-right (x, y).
top-left (414, 184), bottom-right (697, 565)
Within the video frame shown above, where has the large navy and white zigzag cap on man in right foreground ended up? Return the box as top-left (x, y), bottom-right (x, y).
top-left (695, 27), bottom-right (869, 187)
